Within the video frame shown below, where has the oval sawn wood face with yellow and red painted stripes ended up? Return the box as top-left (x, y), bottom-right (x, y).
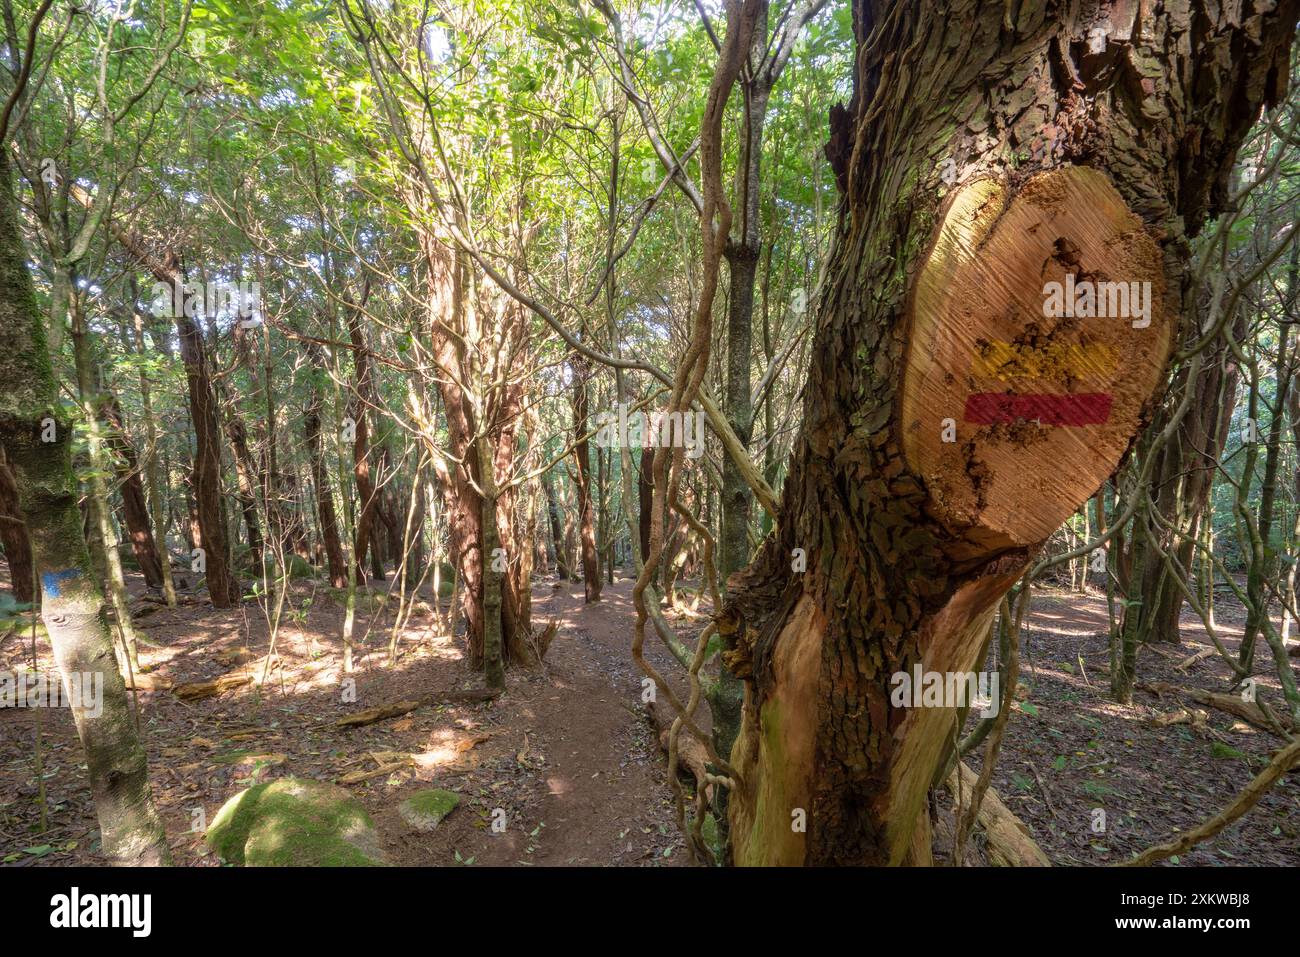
top-left (901, 166), bottom-right (1175, 554)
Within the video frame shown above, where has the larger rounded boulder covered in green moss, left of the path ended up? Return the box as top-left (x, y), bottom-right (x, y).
top-left (207, 778), bottom-right (387, 867)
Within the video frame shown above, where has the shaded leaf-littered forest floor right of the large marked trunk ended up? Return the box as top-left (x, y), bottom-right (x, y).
top-left (969, 589), bottom-right (1300, 866)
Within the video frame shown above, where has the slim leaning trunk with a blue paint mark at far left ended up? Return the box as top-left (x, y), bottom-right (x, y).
top-left (0, 148), bottom-right (169, 865)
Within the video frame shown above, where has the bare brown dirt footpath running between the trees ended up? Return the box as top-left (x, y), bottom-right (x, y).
top-left (371, 579), bottom-right (686, 865)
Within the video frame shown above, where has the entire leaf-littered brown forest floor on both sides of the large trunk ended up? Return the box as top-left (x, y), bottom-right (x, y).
top-left (0, 566), bottom-right (1300, 866)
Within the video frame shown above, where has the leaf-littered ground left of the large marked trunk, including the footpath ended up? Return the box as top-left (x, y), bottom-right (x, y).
top-left (0, 579), bottom-right (689, 866)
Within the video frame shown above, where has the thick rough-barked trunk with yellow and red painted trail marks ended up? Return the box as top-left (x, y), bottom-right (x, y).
top-left (720, 0), bottom-right (1297, 865)
